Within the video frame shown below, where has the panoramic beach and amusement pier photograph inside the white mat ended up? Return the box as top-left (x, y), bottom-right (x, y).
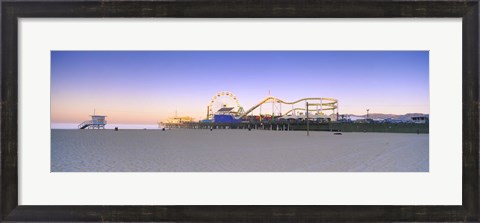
top-left (50, 51), bottom-right (429, 172)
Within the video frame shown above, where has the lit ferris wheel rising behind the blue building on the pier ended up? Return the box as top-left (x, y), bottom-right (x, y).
top-left (208, 91), bottom-right (243, 119)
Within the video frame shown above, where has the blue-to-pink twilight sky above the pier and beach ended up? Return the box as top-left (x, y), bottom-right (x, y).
top-left (51, 51), bottom-right (429, 124)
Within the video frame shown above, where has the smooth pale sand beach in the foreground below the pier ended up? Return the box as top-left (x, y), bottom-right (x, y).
top-left (51, 129), bottom-right (428, 172)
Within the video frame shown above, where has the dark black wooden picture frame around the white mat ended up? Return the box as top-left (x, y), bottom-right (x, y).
top-left (0, 0), bottom-right (480, 222)
